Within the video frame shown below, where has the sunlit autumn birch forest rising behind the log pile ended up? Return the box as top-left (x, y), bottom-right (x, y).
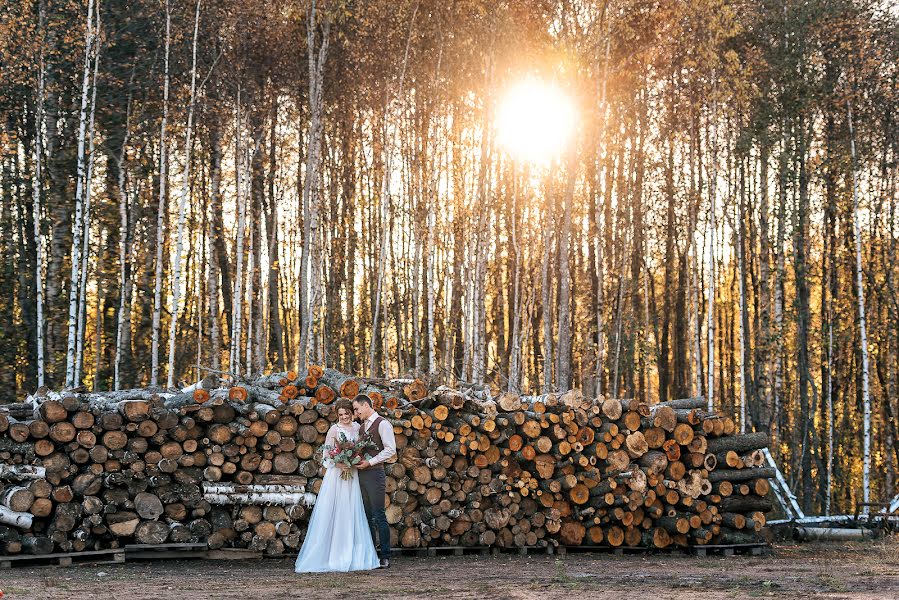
top-left (0, 0), bottom-right (899, 513)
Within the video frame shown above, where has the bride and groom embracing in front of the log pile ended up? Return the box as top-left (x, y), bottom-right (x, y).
top-left (294, 394), bottom-right (396, 573)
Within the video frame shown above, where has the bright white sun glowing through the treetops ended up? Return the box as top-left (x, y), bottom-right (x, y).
top-left (496, 79), bottom-right (575, 165)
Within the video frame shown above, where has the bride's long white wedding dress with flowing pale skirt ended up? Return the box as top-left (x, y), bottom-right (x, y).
top-left (294, 423), bottom-right (380, 573)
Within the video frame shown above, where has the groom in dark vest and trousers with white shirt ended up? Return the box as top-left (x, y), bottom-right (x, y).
top-left (353, 394), bottom-right (396, 569)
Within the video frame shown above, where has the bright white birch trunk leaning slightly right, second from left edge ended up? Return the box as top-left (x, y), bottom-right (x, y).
top-left (66, 0), bottom-right (95, 388)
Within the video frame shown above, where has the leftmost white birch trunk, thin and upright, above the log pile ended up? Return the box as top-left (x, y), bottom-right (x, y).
top-left (31, 0), bottom-right (47, 387)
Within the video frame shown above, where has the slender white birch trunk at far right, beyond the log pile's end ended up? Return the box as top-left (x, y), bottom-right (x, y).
top-left (846, 102), bottom-right (871, 514)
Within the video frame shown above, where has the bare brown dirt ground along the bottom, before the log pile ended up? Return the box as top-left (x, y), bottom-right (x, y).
top-left (0, 538), bottom-right (899, 600)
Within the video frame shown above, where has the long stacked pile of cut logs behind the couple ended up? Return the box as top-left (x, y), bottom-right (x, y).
top-left (0, 367), bottom-right (773, 554)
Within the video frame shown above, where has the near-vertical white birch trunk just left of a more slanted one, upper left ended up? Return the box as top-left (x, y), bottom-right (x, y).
top-left (150, 0), bottom-right (172, 387)
